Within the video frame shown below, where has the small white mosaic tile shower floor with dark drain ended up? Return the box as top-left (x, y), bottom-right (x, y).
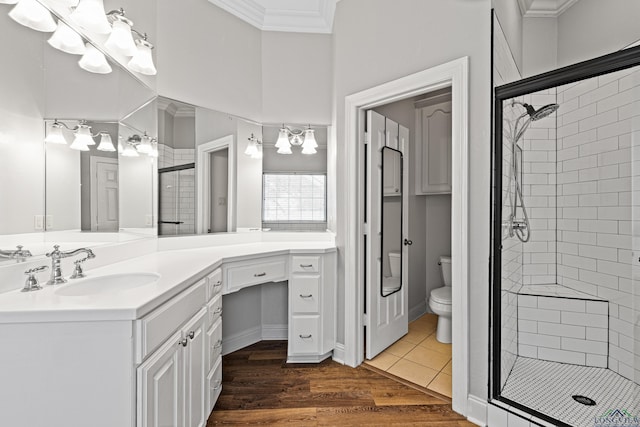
top-left (501, 357), bottom-right (640, 427)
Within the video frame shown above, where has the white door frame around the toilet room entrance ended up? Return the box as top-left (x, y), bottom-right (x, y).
top-left (344, 56), bottom-right (469, 416)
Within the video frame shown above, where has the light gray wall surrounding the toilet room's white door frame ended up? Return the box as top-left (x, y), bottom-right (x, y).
top-left (330, 0), bottom-right (491, 398)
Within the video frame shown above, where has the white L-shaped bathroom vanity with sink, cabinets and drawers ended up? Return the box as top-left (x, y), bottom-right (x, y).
top-left (0, 241), bottom-right (336, 427)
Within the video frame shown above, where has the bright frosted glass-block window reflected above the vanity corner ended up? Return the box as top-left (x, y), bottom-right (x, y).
top-left (262, 173), bottom-right (327, 222)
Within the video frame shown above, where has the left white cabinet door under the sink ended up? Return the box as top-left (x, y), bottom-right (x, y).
top-left (137, 332), bottom-right (184, 427)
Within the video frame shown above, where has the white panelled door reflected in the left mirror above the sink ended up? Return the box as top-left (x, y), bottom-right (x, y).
top-left (91, 156), bottom-right (118, 231)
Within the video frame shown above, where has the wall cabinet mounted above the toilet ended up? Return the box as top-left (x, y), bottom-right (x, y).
top-left (415, 101), bottom-right (451, 195)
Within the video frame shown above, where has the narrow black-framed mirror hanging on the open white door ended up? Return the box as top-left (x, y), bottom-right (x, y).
top-left (380, 146), bottom-right (403, 297)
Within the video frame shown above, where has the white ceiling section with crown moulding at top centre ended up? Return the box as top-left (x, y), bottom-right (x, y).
top-left (209, 0), bottom-right (340, 34)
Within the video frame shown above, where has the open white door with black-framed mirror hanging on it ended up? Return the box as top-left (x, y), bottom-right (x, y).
top-left (365, 111), bottom-right (409, 359)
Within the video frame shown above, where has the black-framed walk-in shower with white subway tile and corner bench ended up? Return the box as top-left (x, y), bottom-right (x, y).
top-left (489, 48), bottom-right (640, 427)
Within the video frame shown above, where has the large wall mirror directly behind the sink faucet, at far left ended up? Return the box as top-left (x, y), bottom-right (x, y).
top-left (0, 5), bottom-right (156, 262)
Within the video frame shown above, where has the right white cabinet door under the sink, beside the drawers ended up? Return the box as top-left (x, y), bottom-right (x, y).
top-left (182, 308), bottom-right (209, 427)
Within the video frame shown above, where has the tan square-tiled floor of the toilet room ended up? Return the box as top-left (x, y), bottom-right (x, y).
top-left (365, 313), bottom-right (451, 397)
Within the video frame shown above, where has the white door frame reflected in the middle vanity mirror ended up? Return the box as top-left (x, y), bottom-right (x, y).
top-left (196, 135), bottom-right (236, 234)
